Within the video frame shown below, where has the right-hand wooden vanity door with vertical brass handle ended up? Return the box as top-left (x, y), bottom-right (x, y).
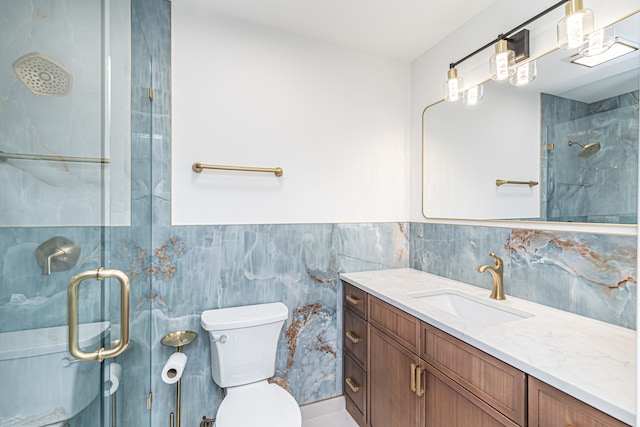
top-left (425, 364), bottom-right (518, 427)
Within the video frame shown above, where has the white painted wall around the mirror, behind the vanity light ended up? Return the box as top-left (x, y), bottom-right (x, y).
top-left (409, 0), bottom-right (640, 224)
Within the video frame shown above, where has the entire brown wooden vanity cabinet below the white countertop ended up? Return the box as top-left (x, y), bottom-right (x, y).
top-left (343, 282), bottom-right (627, 427)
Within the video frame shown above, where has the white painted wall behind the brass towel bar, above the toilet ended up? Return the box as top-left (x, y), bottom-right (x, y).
top-left (171, 0), bottom-right (410, 225)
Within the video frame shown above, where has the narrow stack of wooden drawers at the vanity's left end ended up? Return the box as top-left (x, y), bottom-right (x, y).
top-left (342, 282), bottom-right (368, 427)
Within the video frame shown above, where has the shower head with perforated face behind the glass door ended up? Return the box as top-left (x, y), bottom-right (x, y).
top-left (13, 52), bottom-right (73, 96)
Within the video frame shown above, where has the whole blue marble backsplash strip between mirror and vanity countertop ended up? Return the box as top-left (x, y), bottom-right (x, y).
top-left (410, 223), bottom-right (638, 329)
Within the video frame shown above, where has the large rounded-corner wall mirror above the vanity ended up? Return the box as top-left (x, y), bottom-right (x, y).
top-left (423, 14), bottom-right (640, 224)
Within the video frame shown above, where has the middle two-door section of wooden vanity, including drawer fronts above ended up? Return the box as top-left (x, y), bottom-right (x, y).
top-left (368, 296), bottom-right (526, 427)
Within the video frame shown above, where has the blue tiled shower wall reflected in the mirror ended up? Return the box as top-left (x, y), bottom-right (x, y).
top-left (542, 90), bottom-right (638, 224)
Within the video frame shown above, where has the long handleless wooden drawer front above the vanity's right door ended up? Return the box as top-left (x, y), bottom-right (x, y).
top-left (420, 323), bottom-right (527, 425)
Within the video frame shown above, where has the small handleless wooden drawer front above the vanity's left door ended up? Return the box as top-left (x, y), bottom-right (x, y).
top-left (369, 295), bottom-right (420, 354)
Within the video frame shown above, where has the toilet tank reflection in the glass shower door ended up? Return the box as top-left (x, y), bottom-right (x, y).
top-left (0, 322), bottom-right (109, 426)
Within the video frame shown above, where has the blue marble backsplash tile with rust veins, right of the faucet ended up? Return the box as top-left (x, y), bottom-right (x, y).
top-left (505, 230), bottom-right (637, 328)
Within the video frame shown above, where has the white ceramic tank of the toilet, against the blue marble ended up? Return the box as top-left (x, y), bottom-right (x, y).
top-left (200, 302), bottom-right (289, 388)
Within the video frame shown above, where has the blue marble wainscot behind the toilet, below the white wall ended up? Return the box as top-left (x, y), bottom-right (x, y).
top-left (152, 223), bottom-right (409, 425)
